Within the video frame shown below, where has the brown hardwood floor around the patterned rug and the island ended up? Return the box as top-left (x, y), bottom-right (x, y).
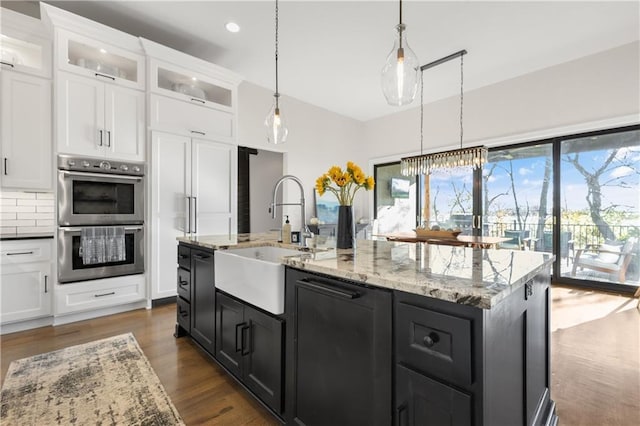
top-left (0, 287), bottom-right (640, 426)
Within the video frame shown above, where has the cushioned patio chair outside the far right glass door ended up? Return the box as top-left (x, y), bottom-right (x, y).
top-left (571, 238), bottom-right (636, 283)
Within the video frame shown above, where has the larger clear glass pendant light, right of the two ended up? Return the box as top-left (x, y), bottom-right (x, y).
top-left (382, 0), bottom-right (420, 106)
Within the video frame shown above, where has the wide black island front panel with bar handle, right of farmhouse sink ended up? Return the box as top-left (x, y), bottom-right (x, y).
top-left (285, 268), bottom-right (392, 426)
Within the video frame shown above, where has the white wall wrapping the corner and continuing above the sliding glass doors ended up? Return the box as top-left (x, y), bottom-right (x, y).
top-left (238, 42), bottom-right (640, 229)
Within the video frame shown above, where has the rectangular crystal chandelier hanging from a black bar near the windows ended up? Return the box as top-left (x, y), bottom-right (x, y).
top-left (400, 50), bottom-right (488, 176)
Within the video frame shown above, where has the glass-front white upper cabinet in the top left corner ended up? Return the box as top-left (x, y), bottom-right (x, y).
top-left (0, 8), bottom-right (51, 77)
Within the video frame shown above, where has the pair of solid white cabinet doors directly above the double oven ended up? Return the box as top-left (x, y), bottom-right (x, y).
top-left (56, 72), bottom-right (145, 161)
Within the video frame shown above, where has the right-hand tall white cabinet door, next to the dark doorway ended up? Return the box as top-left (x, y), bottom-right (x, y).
top-left (191, 139), bottom-right (238, 237)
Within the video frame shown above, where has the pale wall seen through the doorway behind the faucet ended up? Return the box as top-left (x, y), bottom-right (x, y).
top-left (249, 149), bottom-right (283, 232)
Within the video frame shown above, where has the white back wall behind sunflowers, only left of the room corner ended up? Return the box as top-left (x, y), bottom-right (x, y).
top-left (238, 82), bottom-right (369, 230)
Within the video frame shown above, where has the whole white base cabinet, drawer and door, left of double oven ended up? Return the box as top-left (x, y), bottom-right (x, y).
top-left (0, 240), bottom-right (54, 324)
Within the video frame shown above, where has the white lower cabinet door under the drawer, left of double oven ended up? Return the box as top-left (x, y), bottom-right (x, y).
top-left (0, 262), bottom-right (52, 324)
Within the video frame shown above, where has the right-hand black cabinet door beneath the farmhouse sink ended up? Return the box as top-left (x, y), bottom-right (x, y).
top-left (240, 306), bottom-right (283, 413)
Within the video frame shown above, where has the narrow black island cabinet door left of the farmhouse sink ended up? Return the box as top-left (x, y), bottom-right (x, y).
top-left (191, 249), bottom-right (216, 354)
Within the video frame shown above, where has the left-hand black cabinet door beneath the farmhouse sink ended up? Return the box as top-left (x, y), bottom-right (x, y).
top-left (216, 292), bottom-right (248, 377)
